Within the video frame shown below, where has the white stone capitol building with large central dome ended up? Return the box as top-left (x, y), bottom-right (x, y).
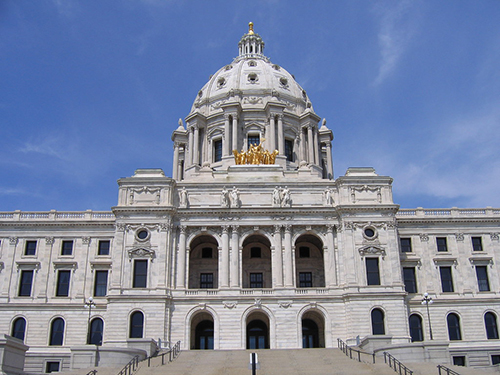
top-left (0, 24), bottom-right (500, 373)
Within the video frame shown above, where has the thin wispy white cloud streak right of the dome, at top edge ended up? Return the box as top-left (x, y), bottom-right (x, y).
top-left (374, 0), bottom-right (416, 85)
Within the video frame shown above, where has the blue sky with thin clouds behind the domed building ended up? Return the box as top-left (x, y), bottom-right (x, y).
top-left (0, 0), bottom-right (500, 211)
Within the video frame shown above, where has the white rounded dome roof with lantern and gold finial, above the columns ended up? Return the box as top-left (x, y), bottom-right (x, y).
top-left (191, 23), bottom-right (312, 117)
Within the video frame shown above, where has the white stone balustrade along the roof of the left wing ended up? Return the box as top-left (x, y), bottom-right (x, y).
top-left (0, 210), bottom-right (116, 222)
